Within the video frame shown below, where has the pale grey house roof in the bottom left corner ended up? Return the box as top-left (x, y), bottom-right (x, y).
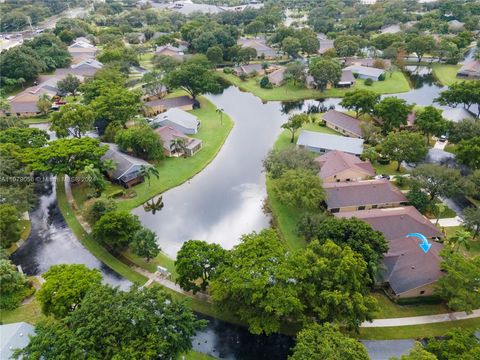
top-left (0, 322), bottom-right (35, 360)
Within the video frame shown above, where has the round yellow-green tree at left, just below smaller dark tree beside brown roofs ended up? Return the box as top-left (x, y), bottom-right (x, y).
top-left (50, 103), bottom-right (95, 138)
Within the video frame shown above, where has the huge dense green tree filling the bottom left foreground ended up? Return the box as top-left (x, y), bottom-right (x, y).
top-left (16, 286), bottom-right (205, 359)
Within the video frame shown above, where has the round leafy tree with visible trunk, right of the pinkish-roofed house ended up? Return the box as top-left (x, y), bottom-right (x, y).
top-left (381, 131), bottom-right (428, 171)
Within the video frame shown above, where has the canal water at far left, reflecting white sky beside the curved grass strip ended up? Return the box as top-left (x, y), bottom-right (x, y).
top-left (11, 178), bottom-right (130, 289)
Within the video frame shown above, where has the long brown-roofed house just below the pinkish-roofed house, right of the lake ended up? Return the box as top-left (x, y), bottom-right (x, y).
top-left (323, 179), bottom-right (408, 213)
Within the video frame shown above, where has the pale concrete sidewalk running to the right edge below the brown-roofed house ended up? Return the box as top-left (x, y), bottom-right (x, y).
top-left (360, 309), bottom-right (480, 327)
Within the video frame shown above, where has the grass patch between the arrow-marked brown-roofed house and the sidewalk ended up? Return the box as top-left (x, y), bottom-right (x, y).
top-left (372, 292), bottom-right (450, 319)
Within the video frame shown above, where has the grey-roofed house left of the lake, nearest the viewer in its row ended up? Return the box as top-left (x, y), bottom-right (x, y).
top-left (101, 144), bottom-right (152, 188)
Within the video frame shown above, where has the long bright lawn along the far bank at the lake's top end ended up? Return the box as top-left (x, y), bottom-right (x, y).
top-left (219, 71), bottom-right (410, 101)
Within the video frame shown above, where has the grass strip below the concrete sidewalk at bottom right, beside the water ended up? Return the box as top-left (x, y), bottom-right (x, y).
top-left (351, 318), bottom-right (480, 340)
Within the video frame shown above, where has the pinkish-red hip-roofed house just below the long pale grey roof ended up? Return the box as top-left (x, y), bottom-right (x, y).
top-left (315, 150), bottom-right (375, 183)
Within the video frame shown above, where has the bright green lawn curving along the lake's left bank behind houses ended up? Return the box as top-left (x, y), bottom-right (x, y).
top-left (113, 97), bottom-right (233, 210)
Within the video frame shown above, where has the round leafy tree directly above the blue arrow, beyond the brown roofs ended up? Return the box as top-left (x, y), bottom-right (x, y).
top-left (411, 164), bottom-right (463, 200)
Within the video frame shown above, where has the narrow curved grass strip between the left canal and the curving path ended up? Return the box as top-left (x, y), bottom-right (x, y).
top-left (57, 177), bottom-right (147, 285)
